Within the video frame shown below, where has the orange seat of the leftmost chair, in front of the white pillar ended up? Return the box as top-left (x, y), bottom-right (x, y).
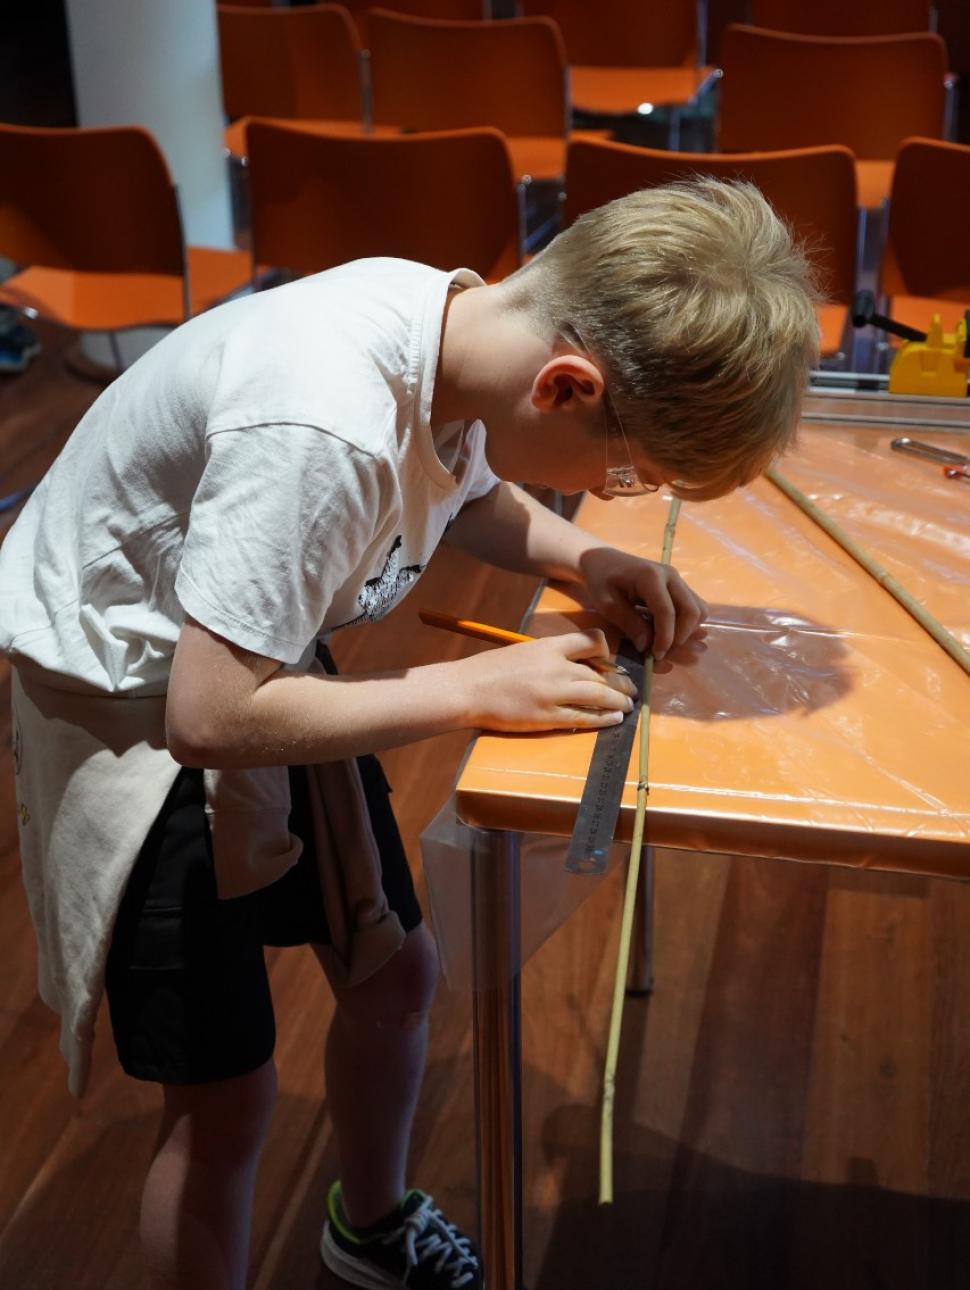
top-left (0, 246), bottom-right (250, 332)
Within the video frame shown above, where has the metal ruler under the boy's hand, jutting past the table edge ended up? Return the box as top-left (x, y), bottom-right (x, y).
top-left (566, 640), bottom-right (644, 875)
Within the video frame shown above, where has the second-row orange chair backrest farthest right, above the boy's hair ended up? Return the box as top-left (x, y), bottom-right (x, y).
top-left (718, 25), bottom-right (947, 160)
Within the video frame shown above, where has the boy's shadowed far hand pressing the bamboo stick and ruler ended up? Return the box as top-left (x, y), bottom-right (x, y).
top-left (580, 547), bottom-right (707, 659)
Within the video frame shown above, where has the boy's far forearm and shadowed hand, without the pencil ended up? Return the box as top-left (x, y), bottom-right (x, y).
top-left (448, 482), bottom-right (707, 659)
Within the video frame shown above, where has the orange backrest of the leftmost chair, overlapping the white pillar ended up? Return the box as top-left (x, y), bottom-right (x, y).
top-left (0, 125), bottom-right (184, 275)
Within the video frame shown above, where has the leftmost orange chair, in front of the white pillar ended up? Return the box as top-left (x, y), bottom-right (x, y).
top-left (0, 125), bottom-right (250, 345)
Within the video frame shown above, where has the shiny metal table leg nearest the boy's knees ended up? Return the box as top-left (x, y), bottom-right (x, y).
top-left (471, 829), bottom-right (522, 1290)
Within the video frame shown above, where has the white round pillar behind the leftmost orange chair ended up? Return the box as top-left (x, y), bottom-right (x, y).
top-left (66, 0), bottom-right (232, 362)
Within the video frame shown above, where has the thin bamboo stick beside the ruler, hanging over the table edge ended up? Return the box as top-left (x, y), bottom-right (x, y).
top-left (600, 497), bottom-right (680, 1205)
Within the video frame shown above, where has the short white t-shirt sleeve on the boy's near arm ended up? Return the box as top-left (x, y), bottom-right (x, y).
top-left (175, 424), bottom-right (384, 663)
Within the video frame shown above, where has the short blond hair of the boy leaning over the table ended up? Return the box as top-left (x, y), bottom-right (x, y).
top-left (510, 177), bottom-right (818, 498)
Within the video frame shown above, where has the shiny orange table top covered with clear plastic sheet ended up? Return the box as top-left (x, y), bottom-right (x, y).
top-left (457, 409), bottom-right (970, 877)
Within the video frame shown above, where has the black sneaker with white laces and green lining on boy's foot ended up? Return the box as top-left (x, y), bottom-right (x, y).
top-left (320, 1182), bottom-right (484, 1290)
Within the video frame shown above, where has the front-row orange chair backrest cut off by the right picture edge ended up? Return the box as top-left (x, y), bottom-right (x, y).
top-left (882, 139), bottom-right (970, 303)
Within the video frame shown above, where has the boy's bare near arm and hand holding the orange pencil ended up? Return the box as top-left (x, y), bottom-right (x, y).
top-left (165, 618), bottom-right (632, 769)
